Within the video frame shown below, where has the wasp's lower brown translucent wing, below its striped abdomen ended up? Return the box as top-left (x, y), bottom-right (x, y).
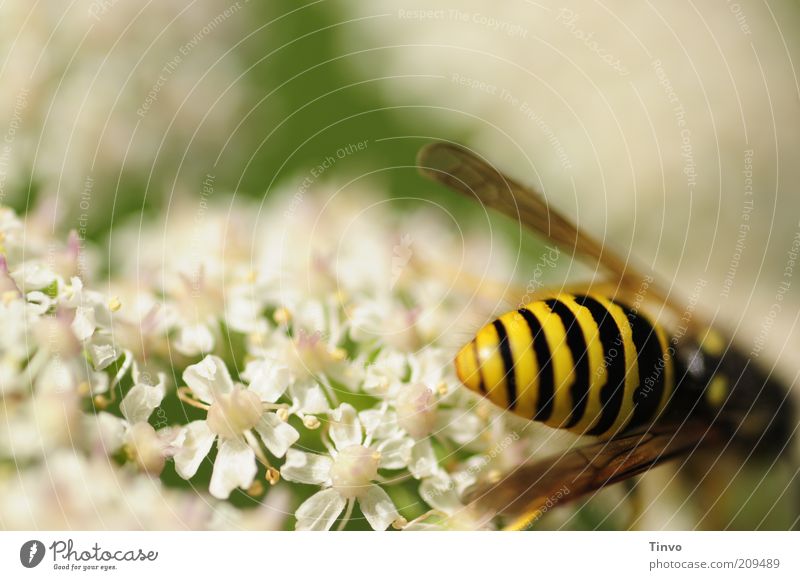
top-left (465, 422), bottom-right (717, 529)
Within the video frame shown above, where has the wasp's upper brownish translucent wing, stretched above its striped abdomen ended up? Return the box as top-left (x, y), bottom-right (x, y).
top-left (417, 143), bottom-right (684, 314)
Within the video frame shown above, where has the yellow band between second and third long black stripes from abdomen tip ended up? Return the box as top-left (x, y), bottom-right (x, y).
top-left (527, 302), bottom-right (575, 427)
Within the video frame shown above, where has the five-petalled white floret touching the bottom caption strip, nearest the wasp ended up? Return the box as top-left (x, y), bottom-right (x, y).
top-left (281, 403), bottom-right (403, 530)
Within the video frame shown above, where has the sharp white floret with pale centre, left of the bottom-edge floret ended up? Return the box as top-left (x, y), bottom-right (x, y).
top-left (175, 355), bottom-right (300, 499)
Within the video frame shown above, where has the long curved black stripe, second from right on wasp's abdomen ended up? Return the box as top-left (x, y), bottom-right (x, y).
top-left (575, 296), bottom-right (626, 435)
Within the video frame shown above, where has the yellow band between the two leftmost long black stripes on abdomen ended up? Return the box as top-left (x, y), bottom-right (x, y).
top-left (500, 310), bottom-right (539, 419)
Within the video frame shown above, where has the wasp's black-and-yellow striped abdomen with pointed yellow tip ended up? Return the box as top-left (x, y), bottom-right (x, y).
top-left (456, 294), bottom-right (675, 437)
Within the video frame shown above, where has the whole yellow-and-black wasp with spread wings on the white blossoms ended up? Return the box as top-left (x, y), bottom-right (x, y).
top-left (418, 143), bottom-right (796, 529)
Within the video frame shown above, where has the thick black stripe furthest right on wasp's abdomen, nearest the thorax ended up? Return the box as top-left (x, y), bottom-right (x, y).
top-left (623, 306), bottom-right (667, 427)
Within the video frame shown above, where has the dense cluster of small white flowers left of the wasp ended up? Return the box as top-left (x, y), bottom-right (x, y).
top-left (0, 188), bottom-right (532, 530)
